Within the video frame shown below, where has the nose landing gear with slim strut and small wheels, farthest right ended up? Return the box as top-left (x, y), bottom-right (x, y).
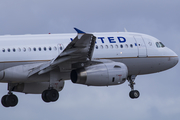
top-left (128, 75), bottom-right (140, 99)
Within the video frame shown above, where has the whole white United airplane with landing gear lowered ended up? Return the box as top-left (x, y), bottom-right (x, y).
top-left (0, 28), bottom-right (179, 107)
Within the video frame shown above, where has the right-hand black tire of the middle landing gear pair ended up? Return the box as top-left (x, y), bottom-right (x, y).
top-left (47, 89), bottom-right (59, 102)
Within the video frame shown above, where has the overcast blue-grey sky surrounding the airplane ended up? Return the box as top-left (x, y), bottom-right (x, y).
top-left (0, 0), bottom-right (180, 120)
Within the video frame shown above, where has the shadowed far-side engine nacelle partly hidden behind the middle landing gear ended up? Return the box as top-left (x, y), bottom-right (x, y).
top-left (8, 81), bottom-right (64, 94)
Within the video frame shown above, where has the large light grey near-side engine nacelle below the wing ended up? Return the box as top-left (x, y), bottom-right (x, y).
top-left (71, 62), bottom-right (128, 86)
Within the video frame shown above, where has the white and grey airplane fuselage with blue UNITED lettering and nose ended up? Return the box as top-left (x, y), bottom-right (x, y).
top-left (0, 32), bottom-right (178, 79)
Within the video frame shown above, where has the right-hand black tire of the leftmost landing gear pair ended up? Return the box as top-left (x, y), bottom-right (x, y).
top-left (6, 94), bottom-right (18, 107)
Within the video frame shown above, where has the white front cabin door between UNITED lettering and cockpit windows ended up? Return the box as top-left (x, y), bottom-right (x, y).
top-left (134, 36), bottom-right (147, 57)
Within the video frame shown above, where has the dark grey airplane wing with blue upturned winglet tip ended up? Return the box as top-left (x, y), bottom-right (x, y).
top-left (28, 28), bottom-right (96, 77)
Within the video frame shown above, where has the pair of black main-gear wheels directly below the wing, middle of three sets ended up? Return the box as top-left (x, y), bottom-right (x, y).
top-left (41, 88), bottom-right (59, 102)
